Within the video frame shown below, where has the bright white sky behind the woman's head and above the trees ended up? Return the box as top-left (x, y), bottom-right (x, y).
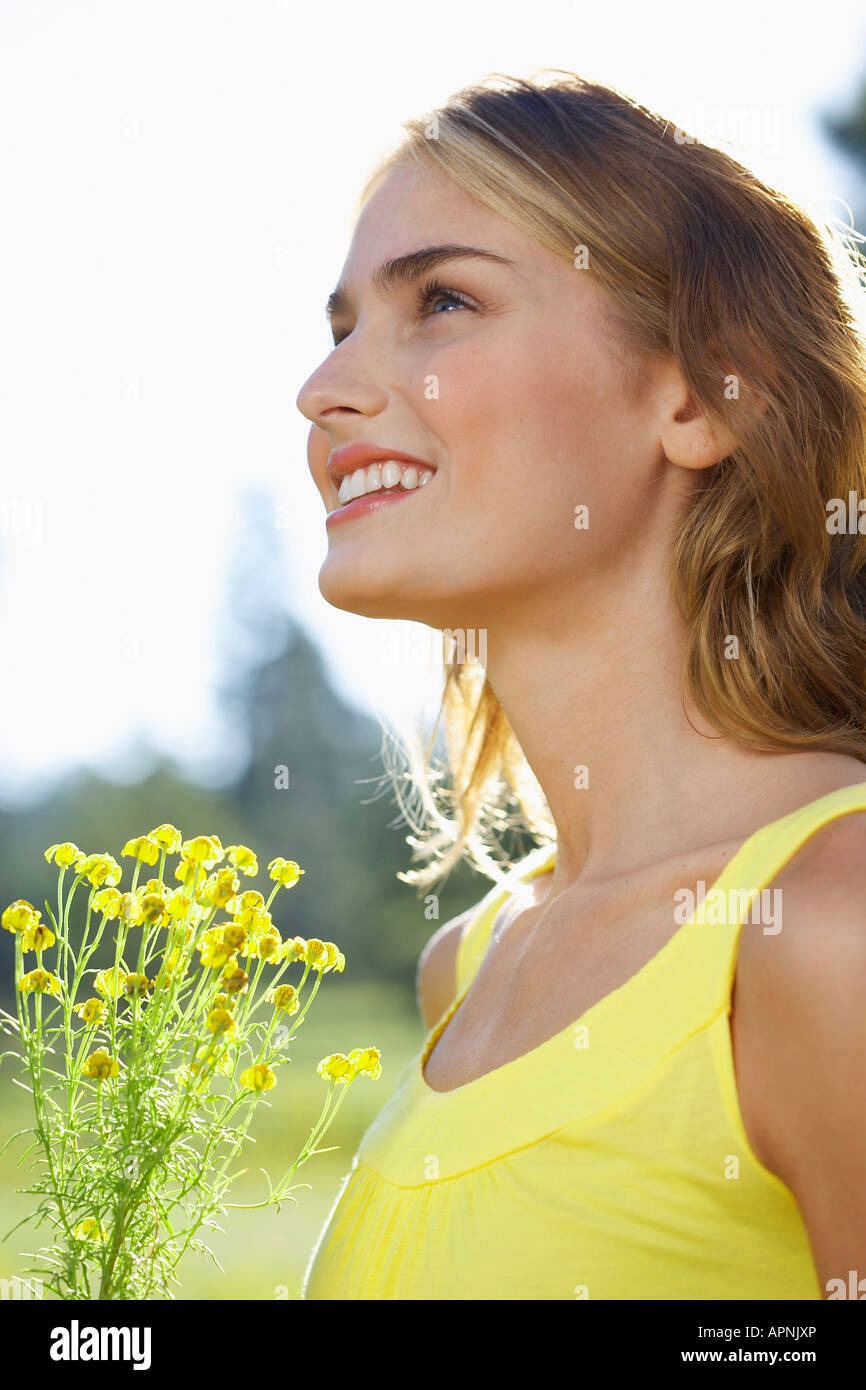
top-left (0, 0), bottom-right (866, 805)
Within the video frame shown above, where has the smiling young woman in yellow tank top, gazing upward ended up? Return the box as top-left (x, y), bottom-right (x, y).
top-left (293, 74), bottom-right (866, 1300)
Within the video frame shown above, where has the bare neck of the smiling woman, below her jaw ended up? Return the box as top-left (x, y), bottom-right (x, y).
top-left (487, 547), bottom-right (866, 895)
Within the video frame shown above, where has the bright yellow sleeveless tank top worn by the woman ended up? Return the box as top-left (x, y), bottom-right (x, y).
top-left (302, 783), bottom-right (866, 1300)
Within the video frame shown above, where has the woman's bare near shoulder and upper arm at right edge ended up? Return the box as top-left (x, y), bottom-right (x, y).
top-left (734, 783), bottom-right (866, 1250)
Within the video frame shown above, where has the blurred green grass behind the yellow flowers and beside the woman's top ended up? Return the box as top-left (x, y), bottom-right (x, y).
top-left (0, 976), bottom-right (425, 1300)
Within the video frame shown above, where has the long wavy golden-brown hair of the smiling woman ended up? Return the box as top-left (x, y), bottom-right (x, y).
top-left (361, 72), bottom-right (866, 890)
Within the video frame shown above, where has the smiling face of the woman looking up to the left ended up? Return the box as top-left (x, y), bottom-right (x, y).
top-left (297, 159), bottom-right (678, 628)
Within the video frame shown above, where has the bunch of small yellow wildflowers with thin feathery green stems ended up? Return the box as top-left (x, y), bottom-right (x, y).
top-left (0, 824), bottom-right (381, 1300)
